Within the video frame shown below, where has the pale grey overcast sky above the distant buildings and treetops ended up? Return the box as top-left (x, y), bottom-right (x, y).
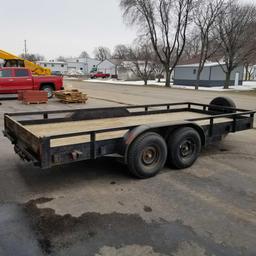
top-left (0, 0), bottom-right (252, 58)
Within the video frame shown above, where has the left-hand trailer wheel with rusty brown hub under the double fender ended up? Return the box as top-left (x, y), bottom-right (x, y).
top-left (127, 132), bottom-right (167, 179)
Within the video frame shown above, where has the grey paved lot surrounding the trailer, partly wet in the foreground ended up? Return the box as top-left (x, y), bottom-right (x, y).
top-left (0, 81), bottom-right (256, 256)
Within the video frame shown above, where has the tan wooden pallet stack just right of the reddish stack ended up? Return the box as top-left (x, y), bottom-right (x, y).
top-left (55, 90), bottom-right (88, 103)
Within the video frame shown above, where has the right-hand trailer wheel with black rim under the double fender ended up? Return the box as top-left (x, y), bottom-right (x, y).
top-left (167, 127), bottom-right (202, 169)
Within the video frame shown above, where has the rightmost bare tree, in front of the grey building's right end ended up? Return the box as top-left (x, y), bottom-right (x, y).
top-left (216, 1), bottom-right (256, 89)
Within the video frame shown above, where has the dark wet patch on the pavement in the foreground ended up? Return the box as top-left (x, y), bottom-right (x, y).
top-left (24, 198), bottom-right (239, 256)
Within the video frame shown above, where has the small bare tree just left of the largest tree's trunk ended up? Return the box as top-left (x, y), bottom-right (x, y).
top-left (126, 43), bottom-right (155, 85)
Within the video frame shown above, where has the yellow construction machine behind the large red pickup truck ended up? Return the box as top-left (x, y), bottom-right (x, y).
top-left (0, 50), bottom-right (52, 75)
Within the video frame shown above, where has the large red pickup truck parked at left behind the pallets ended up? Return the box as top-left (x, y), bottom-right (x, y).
top-left (0, 68), bottom-right (63, 98)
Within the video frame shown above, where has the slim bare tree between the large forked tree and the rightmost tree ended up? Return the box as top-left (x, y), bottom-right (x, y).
top-left (193, 0), bottom-right (225, 90)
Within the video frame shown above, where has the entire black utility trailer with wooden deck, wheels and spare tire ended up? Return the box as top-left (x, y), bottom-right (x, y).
top-left (3, 97), bottom-right (256, 178)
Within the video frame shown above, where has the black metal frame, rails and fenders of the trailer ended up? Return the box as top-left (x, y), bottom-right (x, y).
top-left (3, 102), bottom-right (256, 176)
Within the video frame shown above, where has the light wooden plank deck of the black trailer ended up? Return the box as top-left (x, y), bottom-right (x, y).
top-left (25, 111), bottom-right (230, 147)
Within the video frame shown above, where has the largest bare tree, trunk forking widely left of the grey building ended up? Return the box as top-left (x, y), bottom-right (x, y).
top-left (120, 0), bottom-right (193, 86)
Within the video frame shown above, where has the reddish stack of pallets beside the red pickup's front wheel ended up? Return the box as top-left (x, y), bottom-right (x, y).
top-left (21, 90), bottom-right (48, 104)
